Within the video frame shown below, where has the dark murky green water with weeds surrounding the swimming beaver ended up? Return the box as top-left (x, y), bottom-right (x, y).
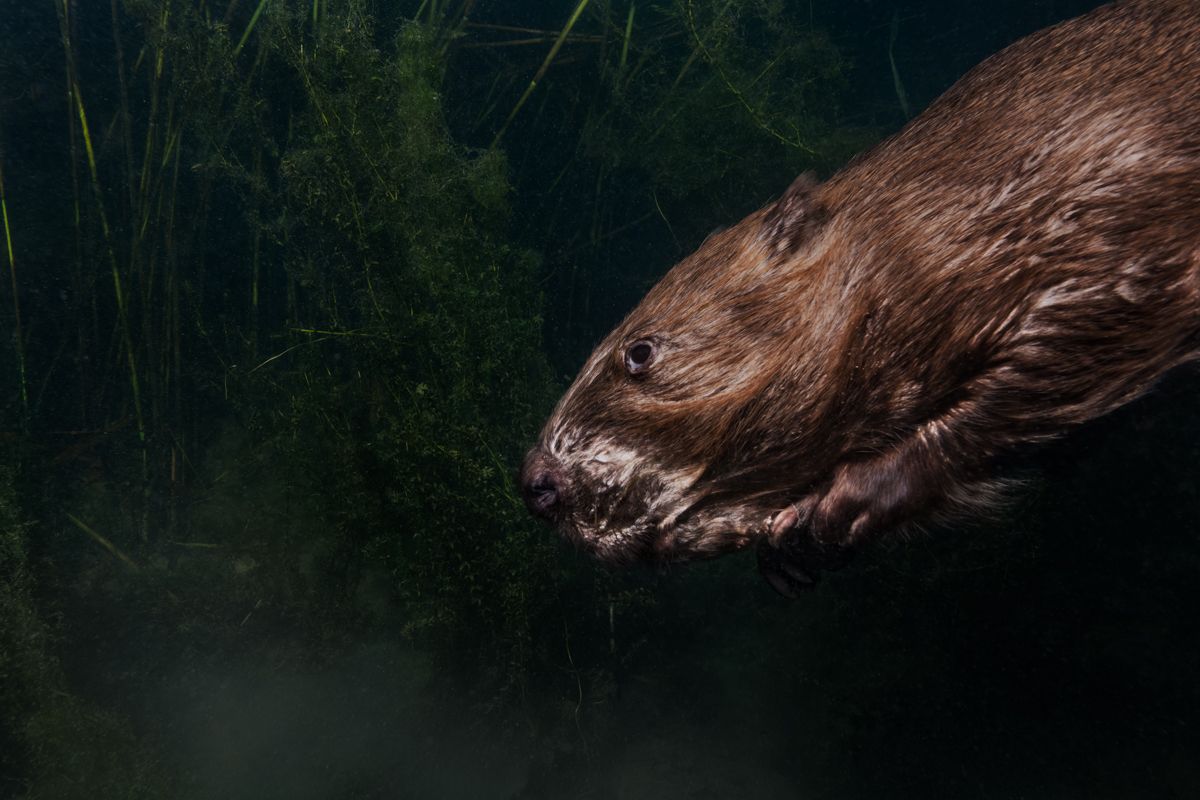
top-left (0, 0), bottom-right (1200, 800)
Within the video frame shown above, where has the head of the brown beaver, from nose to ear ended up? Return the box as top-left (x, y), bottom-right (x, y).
top-left (522, 176), bottom-right (832, 563)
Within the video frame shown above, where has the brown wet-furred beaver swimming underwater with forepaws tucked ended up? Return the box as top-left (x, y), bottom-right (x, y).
top-left (521, 0), bottom-right (1200, 594)
